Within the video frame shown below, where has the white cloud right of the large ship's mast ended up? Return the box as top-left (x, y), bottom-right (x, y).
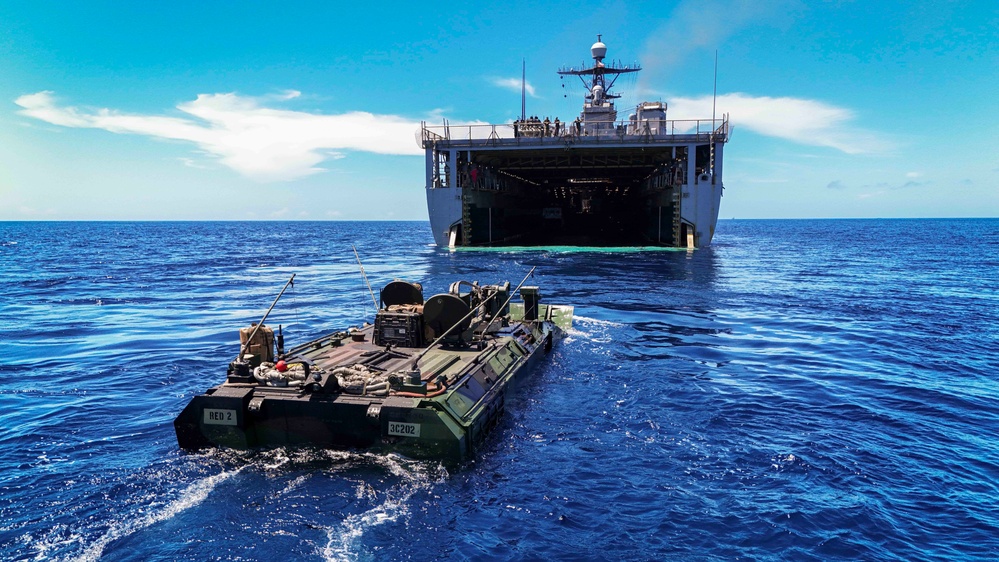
top-left (669, 93), bottom-right (894, 154)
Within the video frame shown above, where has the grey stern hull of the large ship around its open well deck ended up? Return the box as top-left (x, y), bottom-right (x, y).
top-left (424, 131), bottom-right (727, 248)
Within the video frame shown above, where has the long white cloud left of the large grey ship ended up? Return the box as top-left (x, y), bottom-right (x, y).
top-left (14, 90), bottom-right (422, 181)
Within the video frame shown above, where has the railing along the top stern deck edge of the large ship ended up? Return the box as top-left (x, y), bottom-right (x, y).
top-left (417, 114), bottom-right (729, 148)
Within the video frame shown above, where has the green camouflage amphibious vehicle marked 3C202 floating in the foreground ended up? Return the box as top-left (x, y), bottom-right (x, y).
top-left (174, 269), bottom-right (573, 463)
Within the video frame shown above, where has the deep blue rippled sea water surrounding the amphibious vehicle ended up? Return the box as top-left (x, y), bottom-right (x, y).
top-left (0, 219), bottom-right (999, 560)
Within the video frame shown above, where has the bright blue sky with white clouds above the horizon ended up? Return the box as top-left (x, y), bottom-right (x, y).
top-left (0, 0), bottom-right (999, 220)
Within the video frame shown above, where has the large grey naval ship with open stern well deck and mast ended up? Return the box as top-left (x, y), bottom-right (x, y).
top-left (418, 35), bottom-right (729, 248)
